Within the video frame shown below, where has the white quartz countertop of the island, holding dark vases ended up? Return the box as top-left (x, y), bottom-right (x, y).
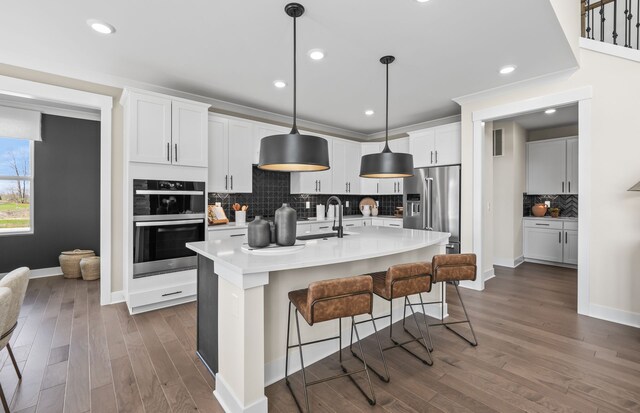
top-left (187, 226), bottom-right (451, 274)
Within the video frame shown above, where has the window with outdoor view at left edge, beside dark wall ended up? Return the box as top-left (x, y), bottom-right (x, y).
top-left (0, 137), bottom-right (33, 232)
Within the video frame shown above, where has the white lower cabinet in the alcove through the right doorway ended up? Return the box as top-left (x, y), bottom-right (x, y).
top-left (524, 219), bottom-right (578, 265)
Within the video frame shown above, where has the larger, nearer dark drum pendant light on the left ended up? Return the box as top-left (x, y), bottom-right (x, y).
top-left (258, 3), bottom-right (329, 172)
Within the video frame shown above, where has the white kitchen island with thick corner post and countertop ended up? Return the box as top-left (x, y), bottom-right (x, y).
top-left (187, 227), bottom-right (450, 413)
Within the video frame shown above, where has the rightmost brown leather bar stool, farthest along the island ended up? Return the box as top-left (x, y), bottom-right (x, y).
top-left (425, 254), bottom-right (478, 349)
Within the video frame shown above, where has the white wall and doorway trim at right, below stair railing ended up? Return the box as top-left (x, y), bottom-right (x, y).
top-left (461, 0), bottom-right (640, 325)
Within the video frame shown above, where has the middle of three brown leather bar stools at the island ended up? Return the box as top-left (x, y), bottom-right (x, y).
top-left (350, 262), bottom-right (433, 382)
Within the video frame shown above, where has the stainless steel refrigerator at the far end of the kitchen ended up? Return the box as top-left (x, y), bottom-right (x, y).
top-left (402, 165), bottom-right (460, 254)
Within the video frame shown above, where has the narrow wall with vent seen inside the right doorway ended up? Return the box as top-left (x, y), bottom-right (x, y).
top-left (496, 121), bottom-right (526, 267)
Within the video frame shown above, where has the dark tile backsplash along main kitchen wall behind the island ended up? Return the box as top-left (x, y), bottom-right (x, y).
top-left (209, 166), bottom-right (402, 221)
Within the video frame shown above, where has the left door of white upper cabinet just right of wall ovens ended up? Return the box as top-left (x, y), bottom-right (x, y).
top-left (207, 116), bottom-right (229, 192)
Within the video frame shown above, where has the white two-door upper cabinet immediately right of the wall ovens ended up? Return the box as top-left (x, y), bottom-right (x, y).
top-left (209, 116), bottom-right (254, 193)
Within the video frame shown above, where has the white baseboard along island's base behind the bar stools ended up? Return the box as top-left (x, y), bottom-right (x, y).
top-left (264, 303), bottom-right (449, 386)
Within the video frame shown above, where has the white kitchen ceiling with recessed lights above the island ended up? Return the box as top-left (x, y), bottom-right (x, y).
top-left (0, 0), bottom-right (577, 134)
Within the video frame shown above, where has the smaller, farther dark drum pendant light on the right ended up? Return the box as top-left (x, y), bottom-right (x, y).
top-left (360, 56), bottom-right (413, 178)
